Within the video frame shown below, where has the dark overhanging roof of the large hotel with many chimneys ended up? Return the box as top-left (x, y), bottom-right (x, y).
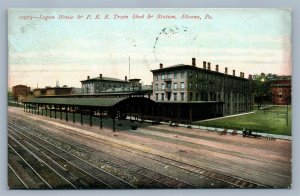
top-left (151, 64), bottom-right (248, 80)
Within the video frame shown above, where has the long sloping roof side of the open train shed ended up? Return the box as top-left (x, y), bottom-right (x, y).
top-left (25, 97), bottom-right (127, 107)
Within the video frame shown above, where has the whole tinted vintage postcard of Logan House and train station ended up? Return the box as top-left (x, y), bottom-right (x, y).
top-left (7, 8), bottom-right (292, 189)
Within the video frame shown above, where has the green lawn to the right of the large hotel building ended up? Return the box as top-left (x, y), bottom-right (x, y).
top-left (194, 106), bottom-right (292, 136)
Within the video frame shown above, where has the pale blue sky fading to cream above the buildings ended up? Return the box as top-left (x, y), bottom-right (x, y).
top-left (8, 8), bottom-right (292, 88)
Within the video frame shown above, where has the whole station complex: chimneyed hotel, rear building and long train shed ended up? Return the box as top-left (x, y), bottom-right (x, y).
top-left (24, 58), bottom-right (253, 125)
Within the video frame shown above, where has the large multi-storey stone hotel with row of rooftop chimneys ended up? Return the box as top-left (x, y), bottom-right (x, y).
top-left (152, 58), bottom-right (253, 115)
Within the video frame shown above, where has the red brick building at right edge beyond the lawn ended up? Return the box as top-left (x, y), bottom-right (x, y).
top-left (271, 76), bottom-right (292, 105)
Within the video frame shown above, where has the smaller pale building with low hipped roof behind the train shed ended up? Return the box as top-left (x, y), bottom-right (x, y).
top-left (80, 74), bottom-right (129, 94)
